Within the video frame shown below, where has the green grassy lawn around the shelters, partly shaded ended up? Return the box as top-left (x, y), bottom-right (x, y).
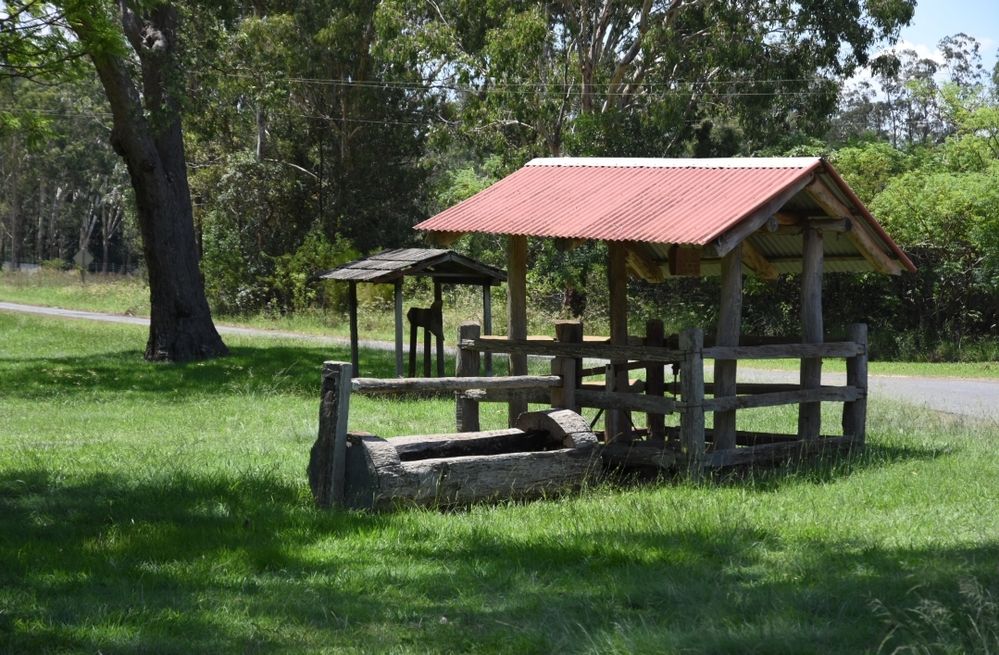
top-left (0, 313), bottom-right (999, 653)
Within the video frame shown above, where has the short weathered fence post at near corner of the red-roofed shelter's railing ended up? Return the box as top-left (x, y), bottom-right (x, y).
top-left (680, 328), bottom-right (705, 479)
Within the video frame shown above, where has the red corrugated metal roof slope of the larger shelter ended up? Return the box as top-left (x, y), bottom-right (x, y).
top-left (416, 157), bottom-right (822, 245)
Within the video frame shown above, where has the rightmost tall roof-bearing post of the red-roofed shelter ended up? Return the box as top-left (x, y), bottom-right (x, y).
top-left (798, 228), bottom-right (822, 439)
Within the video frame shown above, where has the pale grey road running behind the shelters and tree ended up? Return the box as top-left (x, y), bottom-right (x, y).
top-left (0, 302), bottom-right (999, 421)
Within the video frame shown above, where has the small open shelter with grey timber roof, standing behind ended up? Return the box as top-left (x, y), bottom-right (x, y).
top-left (319, 248), bottom-right (506, 377)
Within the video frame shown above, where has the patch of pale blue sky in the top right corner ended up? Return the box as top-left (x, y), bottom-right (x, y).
top-left (899, 0), bottom-right (999, 72)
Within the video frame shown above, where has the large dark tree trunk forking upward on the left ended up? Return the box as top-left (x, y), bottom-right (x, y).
top-left (72, 1), bottom-right (228, 361)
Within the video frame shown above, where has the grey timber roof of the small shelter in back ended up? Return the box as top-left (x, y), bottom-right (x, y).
top-left (319, 248), bottom-right (506, 285)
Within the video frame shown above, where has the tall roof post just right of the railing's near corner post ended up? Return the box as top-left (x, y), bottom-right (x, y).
top-left (713, 244), bottom-right (742, 450)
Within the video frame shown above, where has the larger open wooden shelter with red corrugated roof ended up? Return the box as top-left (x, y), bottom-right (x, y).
top-left (406, 158), bottom-right (915, 462)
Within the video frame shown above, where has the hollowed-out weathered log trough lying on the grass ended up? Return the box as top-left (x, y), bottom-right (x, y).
top-left (345, 410), bottom-right (599, 509)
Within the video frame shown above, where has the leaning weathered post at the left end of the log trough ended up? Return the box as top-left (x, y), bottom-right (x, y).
top-left (308, 362), bottom-right (353, 507)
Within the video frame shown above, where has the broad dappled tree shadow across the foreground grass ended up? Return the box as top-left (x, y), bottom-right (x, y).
top-left (0, 470), bottom-right (999, 653)
